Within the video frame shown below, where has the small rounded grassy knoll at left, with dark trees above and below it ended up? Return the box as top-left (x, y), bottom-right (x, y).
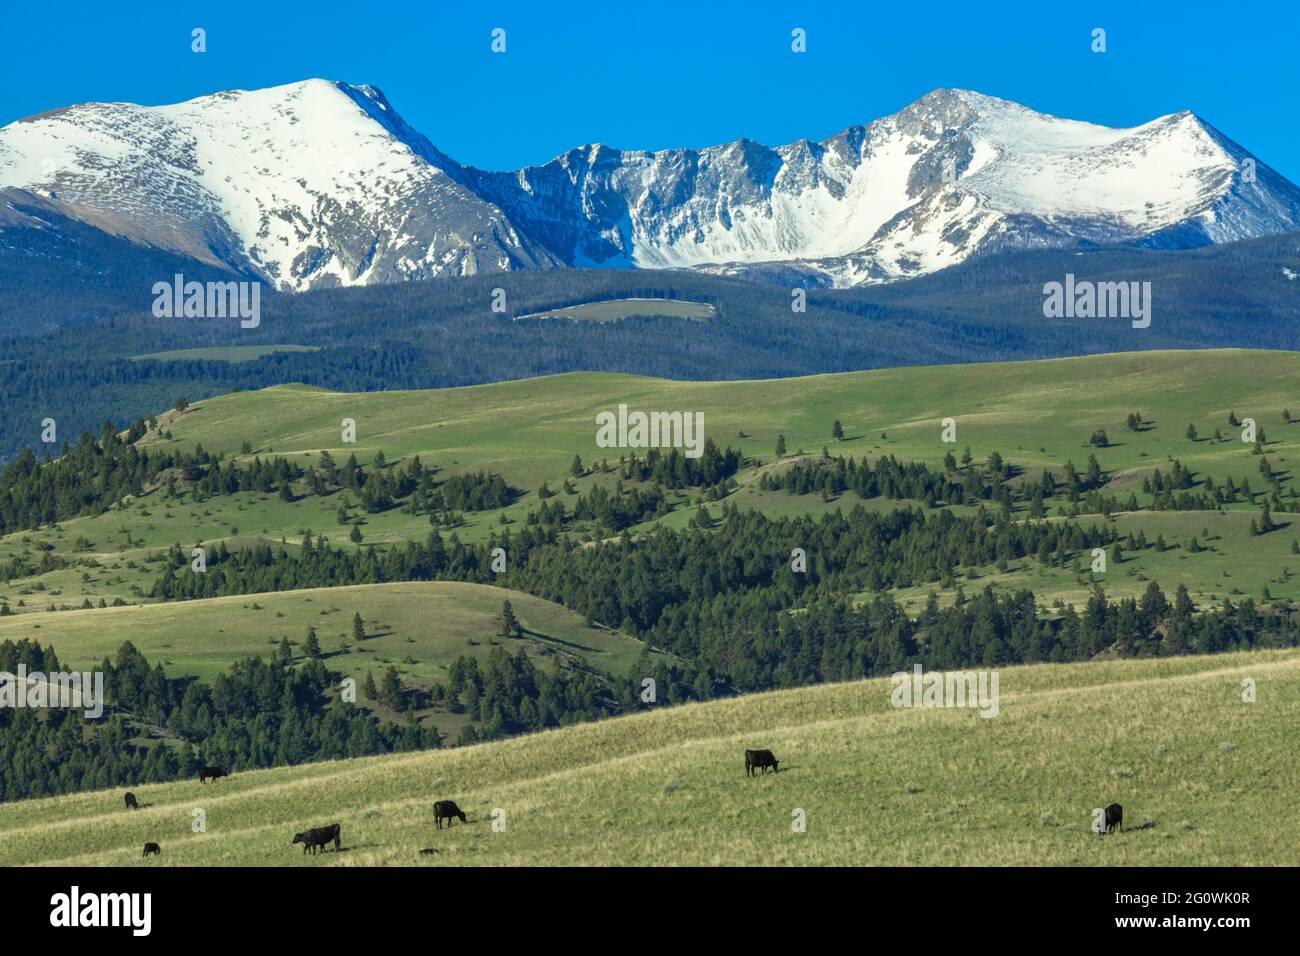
top-left (0, 581), bottom-right (662, 685)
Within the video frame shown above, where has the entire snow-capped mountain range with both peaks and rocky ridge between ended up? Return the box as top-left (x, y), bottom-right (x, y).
top-left (0, 79), bottom-right (1300, 291)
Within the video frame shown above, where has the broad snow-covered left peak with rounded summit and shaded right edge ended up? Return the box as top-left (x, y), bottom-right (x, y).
top-left (0, 79), bottom-right (554, 291)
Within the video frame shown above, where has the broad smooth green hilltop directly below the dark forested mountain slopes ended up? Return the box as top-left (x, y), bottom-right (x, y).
top-left (142, 350), bottom-right (1300, 490)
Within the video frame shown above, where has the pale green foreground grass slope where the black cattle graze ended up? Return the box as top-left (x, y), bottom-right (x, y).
top-left (0, 650), bottom-right (1300, 866)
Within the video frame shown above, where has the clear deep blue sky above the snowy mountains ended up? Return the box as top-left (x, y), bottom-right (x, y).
top-left (0, 0), bottom-right (1300, 182)
